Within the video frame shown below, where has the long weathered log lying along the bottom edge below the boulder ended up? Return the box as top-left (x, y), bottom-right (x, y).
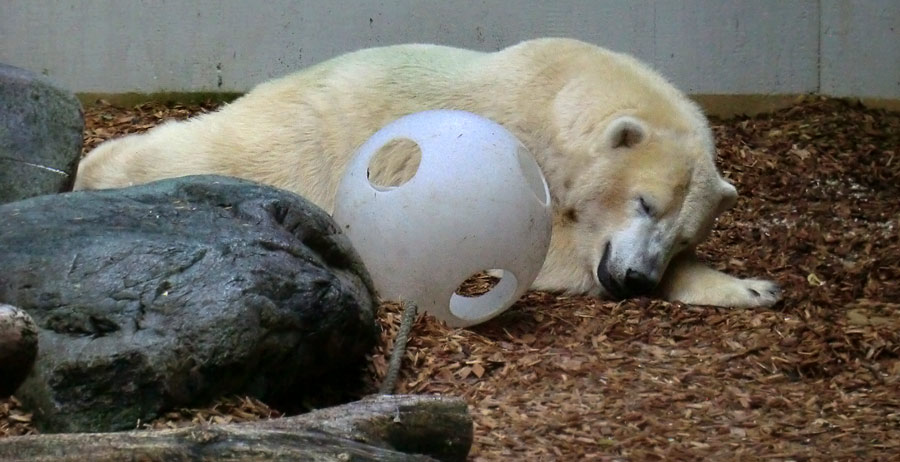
top-left (0, 395), bottom-right (473, 462)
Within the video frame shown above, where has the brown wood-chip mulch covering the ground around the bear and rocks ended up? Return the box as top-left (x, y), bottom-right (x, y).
top-left (0, 98), bottom-right (900, 461)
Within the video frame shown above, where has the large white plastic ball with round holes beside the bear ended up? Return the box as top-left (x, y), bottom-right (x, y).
top-left (334, 110), bottom-right (552, 327)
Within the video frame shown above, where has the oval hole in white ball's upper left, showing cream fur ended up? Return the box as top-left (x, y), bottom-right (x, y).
top-left (367, 138), bottom-right (422, 191)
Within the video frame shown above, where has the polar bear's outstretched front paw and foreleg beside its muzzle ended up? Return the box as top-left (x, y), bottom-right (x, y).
top-left (659, 253), bottom-right (781, 308)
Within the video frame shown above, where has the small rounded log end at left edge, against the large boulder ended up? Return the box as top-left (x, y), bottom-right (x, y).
top-left (0, 303), bottom-right (37, 398)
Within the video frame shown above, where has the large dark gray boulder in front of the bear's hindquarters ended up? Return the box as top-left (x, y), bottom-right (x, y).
top-left (0, 176), bottom-right (377, 432)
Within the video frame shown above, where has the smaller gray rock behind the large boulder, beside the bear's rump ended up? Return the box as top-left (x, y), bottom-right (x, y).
top-left (0, 64), bottom-right (84, 203)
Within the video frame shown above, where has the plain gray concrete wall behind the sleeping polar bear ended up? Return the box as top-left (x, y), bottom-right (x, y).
top-left (0, 0), bottom-right (900, 99)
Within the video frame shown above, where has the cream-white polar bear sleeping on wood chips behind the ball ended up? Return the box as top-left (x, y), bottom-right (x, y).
top-left (75, 39), bottom-right (780, 307)
